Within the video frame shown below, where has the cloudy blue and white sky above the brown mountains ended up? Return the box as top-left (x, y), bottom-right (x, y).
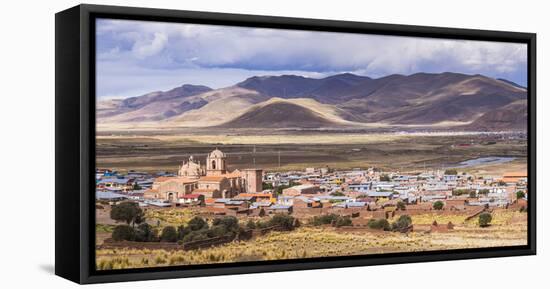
top-left (96, 19), bottom-right (527, 99)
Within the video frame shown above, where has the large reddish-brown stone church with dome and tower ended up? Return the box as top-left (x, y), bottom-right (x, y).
top-left (144, 149), bottom-right (263, 203)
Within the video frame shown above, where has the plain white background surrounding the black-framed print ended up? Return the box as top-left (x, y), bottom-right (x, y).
top-left (0, 0), bottom-right (550, 289)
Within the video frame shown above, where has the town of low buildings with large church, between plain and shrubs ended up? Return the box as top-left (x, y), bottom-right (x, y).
top-left (96, 149), bottom-right (527, 215)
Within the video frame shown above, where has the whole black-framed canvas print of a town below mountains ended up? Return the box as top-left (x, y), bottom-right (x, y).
top-left (55, 5), bottom-right (536, 283)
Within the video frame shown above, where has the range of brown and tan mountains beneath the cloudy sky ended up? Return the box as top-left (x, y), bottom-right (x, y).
top-left (97, 72), bottom-right (527, 131)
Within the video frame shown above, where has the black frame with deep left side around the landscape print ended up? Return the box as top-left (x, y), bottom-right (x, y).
top-left (55, 4), bottom-right (536, 284)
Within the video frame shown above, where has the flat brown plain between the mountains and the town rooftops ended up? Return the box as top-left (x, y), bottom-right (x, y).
top-left (97, 133), bottom-right (527, 172)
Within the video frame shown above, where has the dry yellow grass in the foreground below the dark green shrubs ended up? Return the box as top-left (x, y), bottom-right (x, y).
top-left (96, 210), bottom-right (527, 269)
